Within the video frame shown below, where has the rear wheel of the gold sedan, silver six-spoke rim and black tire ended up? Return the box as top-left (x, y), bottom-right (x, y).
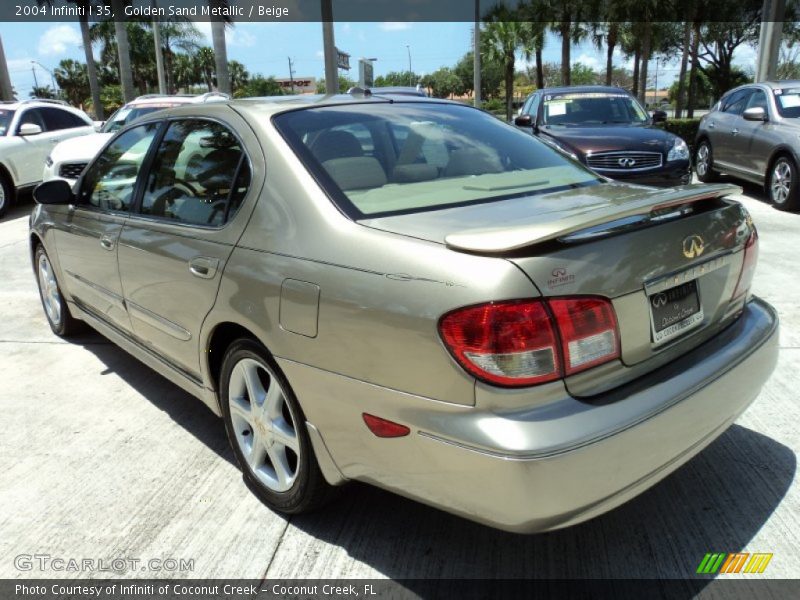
top-left (220, 338), bottom-right (336, 515)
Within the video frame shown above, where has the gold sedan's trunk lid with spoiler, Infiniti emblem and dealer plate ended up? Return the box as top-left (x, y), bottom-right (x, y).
top-left (362, 183), bottom-right (752, 397)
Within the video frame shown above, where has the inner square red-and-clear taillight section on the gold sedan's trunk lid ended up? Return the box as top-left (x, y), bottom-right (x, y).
top-left (550, 297), bottom-right (619, 375)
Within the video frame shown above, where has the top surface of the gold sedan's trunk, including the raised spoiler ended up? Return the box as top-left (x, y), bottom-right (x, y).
top-left (359, 182), bottom-right (741, 254)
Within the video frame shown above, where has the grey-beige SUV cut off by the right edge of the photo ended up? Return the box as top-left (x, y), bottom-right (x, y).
top-left (695, 81), bottom-right (800, 210)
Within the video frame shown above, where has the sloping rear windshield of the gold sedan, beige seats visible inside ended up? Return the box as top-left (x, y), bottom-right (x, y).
top-left (274, 102), bottom-right (600, 219)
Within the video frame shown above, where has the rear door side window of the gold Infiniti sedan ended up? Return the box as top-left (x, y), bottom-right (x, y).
top-left (141, 119), bottom-right (250, 226)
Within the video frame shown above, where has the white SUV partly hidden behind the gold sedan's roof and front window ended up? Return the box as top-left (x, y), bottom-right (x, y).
top-left (42, 92), bottom-right (230, 184)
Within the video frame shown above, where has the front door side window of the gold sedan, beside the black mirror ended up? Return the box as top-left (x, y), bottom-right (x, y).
top-left (78, 123), bottom-right (159, 212)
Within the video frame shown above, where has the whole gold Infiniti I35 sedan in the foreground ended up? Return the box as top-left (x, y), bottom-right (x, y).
top-left (30, 92), bottom-right (778, 532)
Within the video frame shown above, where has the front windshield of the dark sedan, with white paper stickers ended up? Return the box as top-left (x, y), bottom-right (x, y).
top-left (542, 92), bottom-right (649, 125)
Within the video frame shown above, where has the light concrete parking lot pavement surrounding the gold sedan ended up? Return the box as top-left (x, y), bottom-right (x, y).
top-left (0, 186), bottom-right (800, 585)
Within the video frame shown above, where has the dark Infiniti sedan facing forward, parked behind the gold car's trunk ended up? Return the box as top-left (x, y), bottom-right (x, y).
top-left (514, 86), bottom-right (691, 186)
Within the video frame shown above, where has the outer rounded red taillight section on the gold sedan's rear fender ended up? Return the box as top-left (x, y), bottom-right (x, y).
top-left (439, 300), bottom-right (561, 386)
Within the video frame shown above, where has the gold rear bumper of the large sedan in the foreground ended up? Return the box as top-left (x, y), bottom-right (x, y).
top-left (282, 299), bottom-right (778, 532)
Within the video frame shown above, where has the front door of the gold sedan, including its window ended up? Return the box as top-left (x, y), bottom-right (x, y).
top-left (55, 124), bottom-right (158, 333)
